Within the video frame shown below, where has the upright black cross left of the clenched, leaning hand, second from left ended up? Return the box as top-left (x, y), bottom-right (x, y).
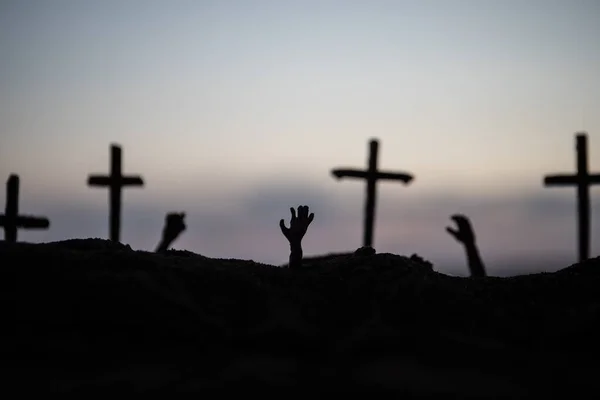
top-left (88, 144), bottom-right (144, 242)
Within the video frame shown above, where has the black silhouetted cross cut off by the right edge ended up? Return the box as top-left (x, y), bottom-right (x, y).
top-left (544, 132), bottom-right (600, 261)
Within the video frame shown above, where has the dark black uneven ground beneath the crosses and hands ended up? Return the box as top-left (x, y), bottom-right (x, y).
top-left (0, 239), bottom-right (600, 398)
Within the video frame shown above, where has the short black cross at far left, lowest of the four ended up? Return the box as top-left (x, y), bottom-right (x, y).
top-left (0, 174), bottom-right (50, 243)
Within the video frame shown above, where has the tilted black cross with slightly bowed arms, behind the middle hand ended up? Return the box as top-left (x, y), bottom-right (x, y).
top-left (331, 139), bottom-right (413, 247)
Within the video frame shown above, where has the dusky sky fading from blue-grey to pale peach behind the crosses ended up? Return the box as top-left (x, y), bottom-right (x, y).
top-left (0, 0), bottom-right (600, 276)
